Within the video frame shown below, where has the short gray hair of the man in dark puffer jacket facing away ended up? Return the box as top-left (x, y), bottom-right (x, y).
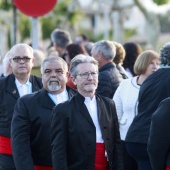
top-left (92, 40), bottom-right (116, 60)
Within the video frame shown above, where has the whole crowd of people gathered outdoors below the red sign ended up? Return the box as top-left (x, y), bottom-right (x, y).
top-left (0, 28), bottom-right (170, 170)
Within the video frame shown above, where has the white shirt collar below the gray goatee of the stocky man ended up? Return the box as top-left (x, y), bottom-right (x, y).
top-left (48, 89), bottom-right (69, 105)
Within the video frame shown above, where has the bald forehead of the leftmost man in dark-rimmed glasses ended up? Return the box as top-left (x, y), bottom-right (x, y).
top-left (11, 46), bottom-right (33, 58)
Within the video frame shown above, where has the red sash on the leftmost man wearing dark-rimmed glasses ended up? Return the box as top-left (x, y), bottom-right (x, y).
top-left (0, 136), bottom-right (12, 155)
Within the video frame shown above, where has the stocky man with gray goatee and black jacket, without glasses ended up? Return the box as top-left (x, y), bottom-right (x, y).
top-left (11, 56), bottom-right (76, 170)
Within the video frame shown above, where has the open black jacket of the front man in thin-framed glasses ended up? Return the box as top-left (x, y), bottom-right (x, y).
top-left (51, 93), bottom-right (123, 170)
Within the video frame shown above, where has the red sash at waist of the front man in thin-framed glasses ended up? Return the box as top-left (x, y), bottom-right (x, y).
top-left (94, 143), bottom-right (108, 170)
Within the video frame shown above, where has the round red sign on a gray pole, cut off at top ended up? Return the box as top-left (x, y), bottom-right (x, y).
top-left (14, 0), bottom-right (57, 17)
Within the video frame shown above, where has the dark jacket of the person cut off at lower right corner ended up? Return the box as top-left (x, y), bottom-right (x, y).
top-left (148, 98), bottom-right (170, 170)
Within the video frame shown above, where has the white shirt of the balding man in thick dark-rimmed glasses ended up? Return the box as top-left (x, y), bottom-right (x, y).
top-left (15, 78), bottom-right (32, 97)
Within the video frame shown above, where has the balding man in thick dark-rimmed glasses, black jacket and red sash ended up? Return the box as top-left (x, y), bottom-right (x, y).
top-left (0, 44), bottom-right (42, 170)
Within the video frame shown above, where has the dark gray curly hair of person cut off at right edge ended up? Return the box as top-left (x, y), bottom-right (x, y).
top-left (160, 42), bottom-right (170, 66)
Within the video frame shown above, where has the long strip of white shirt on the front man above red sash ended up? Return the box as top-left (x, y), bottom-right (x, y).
top-left (84, 96), bottom-right (104, 143)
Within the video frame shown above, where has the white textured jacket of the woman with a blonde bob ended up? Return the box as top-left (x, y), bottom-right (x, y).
top-left (113, 76), bottom-right (140, 140)
